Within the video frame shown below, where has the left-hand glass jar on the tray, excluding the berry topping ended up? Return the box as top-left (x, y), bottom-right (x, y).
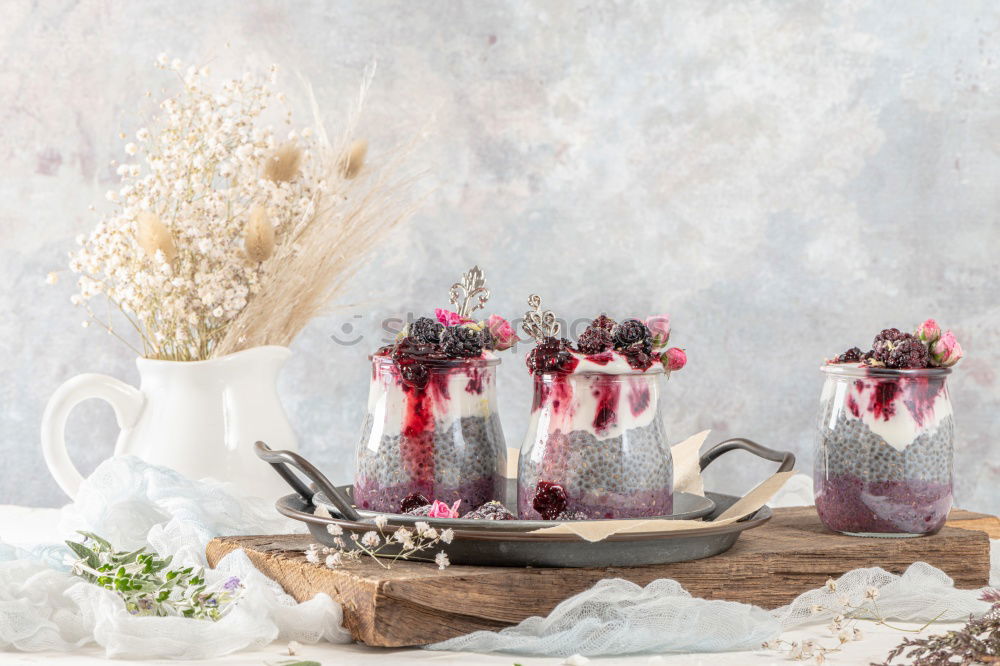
top-left (354, 356), bottom-right (507, 513)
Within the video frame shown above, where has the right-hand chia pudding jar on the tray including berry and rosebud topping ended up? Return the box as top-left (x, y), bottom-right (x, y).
top-left (518, 315), bottom-right (683, 520)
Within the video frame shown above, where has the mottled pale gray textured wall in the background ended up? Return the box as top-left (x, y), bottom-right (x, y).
top-left (0, 0), bottom-right (1000, 511)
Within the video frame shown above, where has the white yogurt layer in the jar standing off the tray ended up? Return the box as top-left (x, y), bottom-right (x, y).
top-left (820, 377), bottom-right (952, 451)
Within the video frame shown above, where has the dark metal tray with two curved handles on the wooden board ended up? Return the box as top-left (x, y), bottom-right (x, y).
top-left (256, 438), bottom-right (795, 567)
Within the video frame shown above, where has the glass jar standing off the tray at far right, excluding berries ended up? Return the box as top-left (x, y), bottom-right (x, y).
top-left (813, 364), bottom-right (955, 536)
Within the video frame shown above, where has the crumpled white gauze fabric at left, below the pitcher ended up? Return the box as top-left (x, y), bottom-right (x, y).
top-left (0, 457), bottom-right (351, 659)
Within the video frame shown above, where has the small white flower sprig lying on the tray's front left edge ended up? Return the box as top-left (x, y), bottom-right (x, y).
top-left (305, 516), bottom-right (455, 569)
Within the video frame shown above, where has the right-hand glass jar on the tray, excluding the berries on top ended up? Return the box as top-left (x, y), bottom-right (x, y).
top-left (517, 364), bottom-right (673, 520)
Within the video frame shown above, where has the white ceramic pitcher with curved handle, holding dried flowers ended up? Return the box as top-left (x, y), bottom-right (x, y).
top-left (42, 346), bottom-right (297, 499)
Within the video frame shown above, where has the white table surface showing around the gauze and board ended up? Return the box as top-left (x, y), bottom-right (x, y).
top-left (0, 505), bottom-right (961, 666)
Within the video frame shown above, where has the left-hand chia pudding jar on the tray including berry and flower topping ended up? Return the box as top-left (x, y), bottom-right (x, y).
top-left (354, 310), bottom-right (516, 513)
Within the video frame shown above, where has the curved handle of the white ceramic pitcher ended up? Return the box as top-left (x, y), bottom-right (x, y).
top-left (42, 373), bottom-right (144, 499)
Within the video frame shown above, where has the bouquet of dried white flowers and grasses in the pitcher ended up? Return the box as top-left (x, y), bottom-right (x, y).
top-left (70, 55), bottom-right (413, 361)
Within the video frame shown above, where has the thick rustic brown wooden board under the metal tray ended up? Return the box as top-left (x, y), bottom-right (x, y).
top-left (208, 507), bottom-right (1000, 647)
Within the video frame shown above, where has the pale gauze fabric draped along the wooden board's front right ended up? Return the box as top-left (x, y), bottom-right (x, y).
top-left (428, 474), bottom-right (1000, 657)
